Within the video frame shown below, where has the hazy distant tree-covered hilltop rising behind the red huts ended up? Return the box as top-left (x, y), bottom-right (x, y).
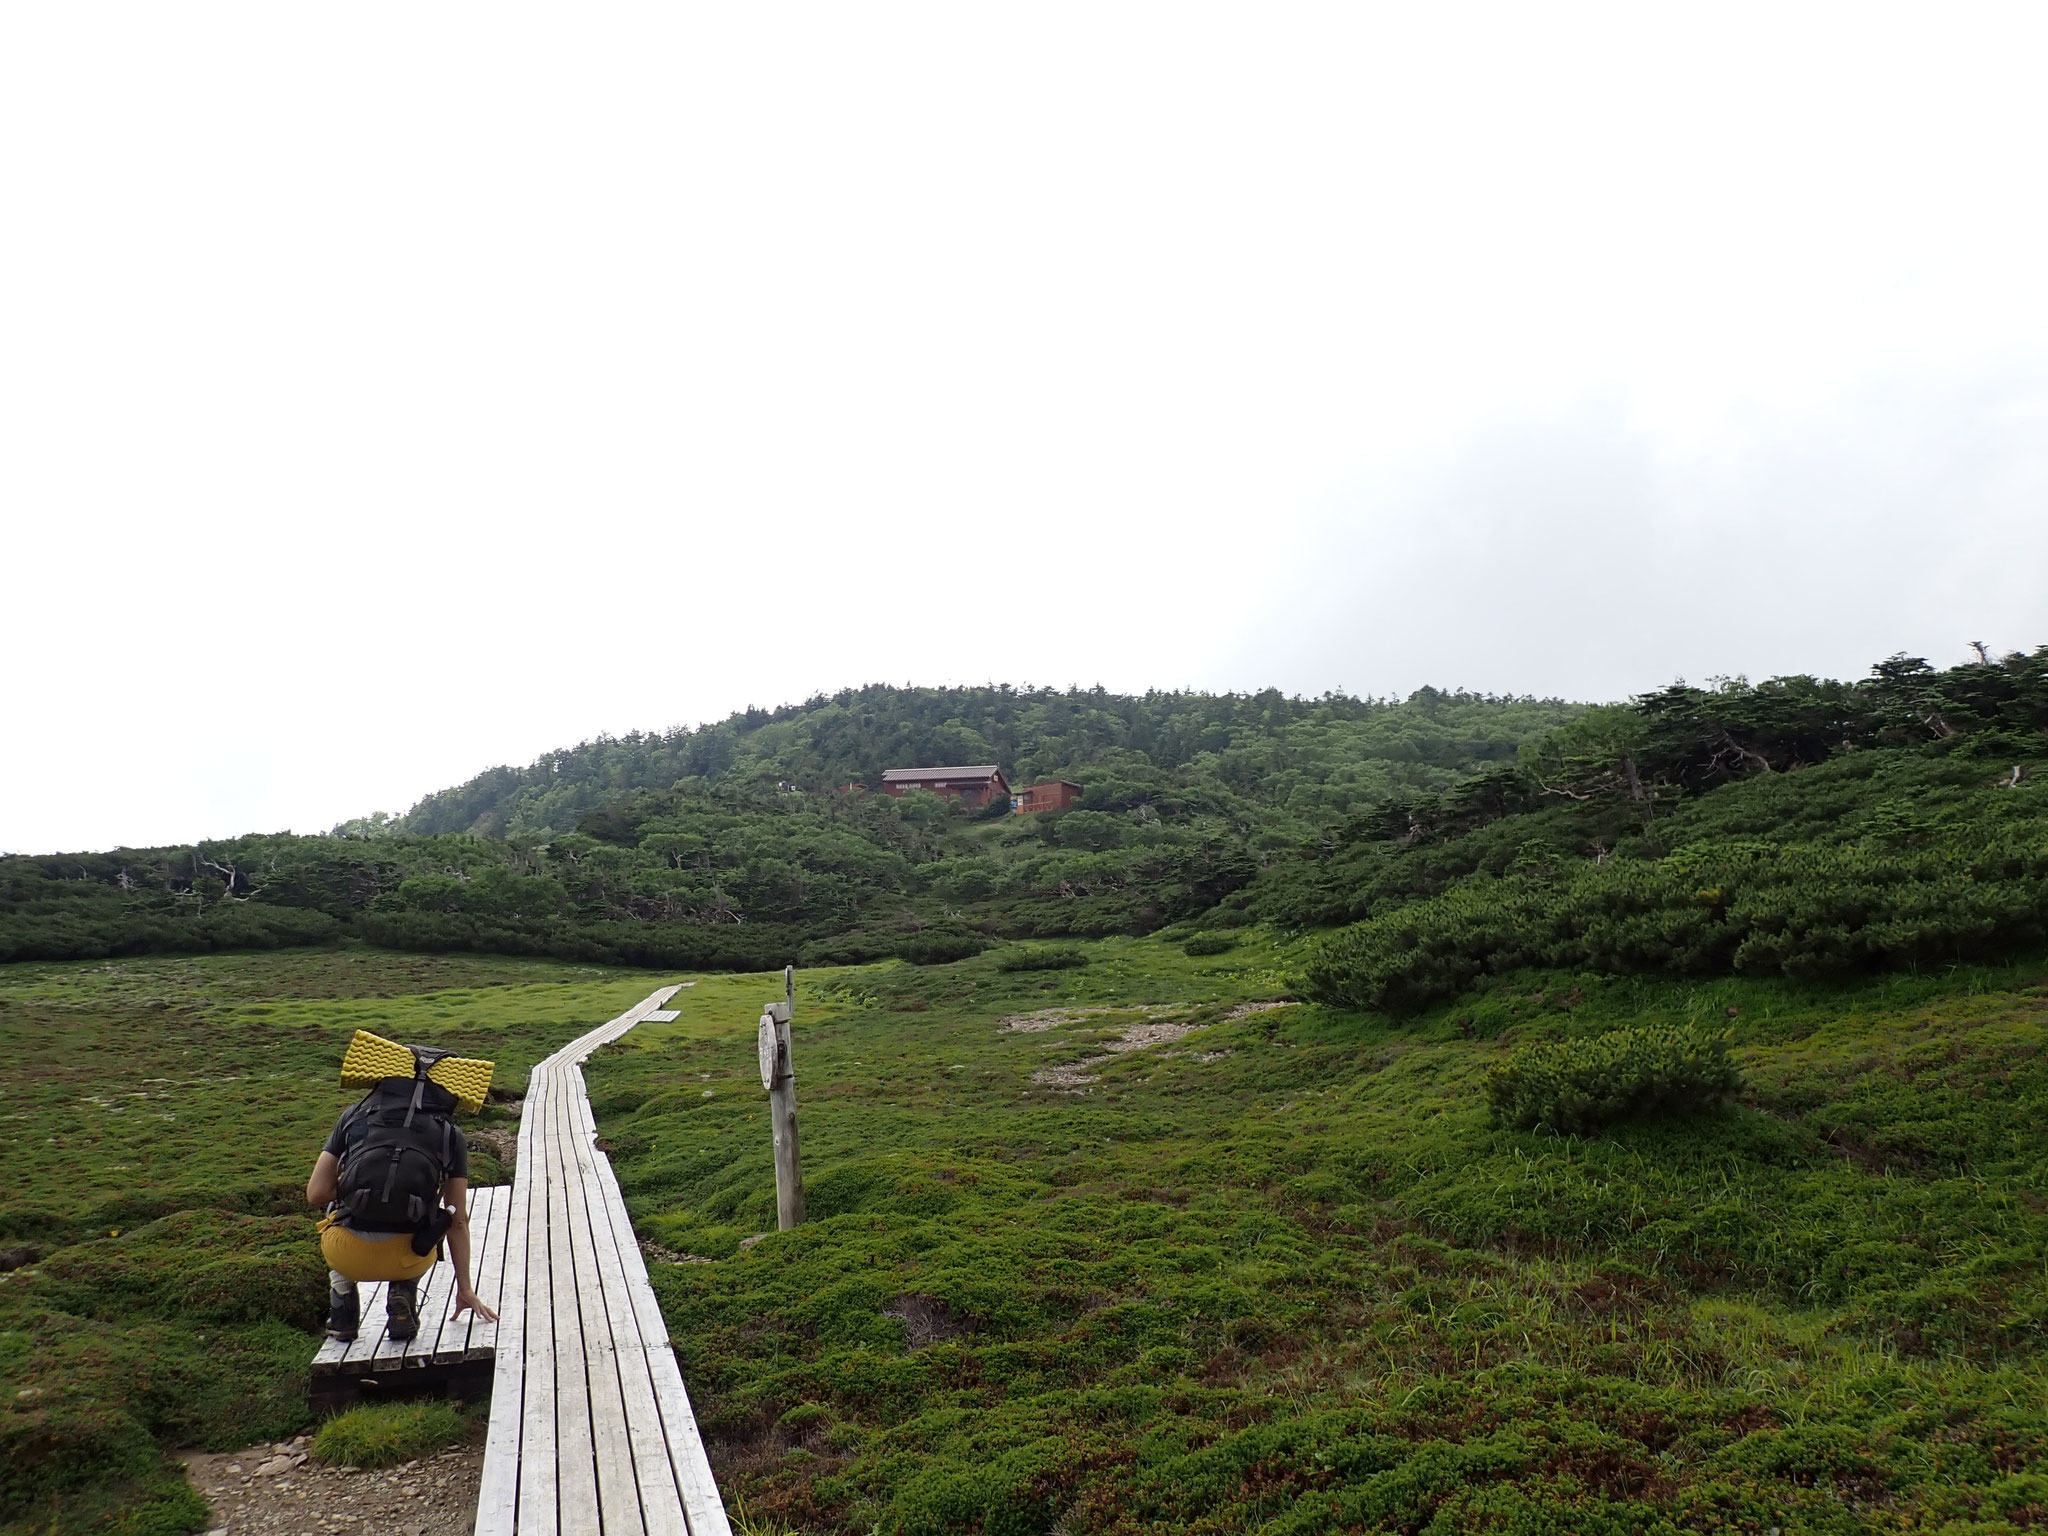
top-left (391, 684), bottom-right (1579, 840)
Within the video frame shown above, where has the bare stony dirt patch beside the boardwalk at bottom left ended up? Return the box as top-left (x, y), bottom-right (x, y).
top-left (184, 1436), bottom-right (483, 1536)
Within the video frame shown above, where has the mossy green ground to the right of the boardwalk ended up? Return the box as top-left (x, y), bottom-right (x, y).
top-left (588, 934), bottom-right (2048, 1536)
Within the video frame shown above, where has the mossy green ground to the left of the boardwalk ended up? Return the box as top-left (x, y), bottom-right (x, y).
top-left (0, 948), bottom-right (657, 1536)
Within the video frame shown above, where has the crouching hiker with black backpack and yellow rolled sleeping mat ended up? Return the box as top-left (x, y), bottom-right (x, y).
top-left (305, 1030), bottom-right (498, 1339)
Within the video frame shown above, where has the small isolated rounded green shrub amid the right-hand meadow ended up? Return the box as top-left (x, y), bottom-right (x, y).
top-left (1487, 1026), bottom-right (1743, 1135)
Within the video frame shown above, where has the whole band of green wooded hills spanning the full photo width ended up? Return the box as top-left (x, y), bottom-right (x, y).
top-left (0, 647), bottom-right (2048, 1010)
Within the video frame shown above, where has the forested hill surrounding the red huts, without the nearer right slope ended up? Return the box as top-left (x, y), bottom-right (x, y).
top-left (0, 686), bottom-right (1581, 967)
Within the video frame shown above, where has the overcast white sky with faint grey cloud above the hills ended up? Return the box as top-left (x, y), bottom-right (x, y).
top-left (0, 4), bottom-right (2048, 852)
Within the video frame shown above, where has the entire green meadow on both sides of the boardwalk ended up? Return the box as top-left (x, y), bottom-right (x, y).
top-left (0, 946), bottom-right (2048, 1536)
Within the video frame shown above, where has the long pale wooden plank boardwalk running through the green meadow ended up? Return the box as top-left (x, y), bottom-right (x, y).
top-left (475, 987), bottom-right (731, 1536)
